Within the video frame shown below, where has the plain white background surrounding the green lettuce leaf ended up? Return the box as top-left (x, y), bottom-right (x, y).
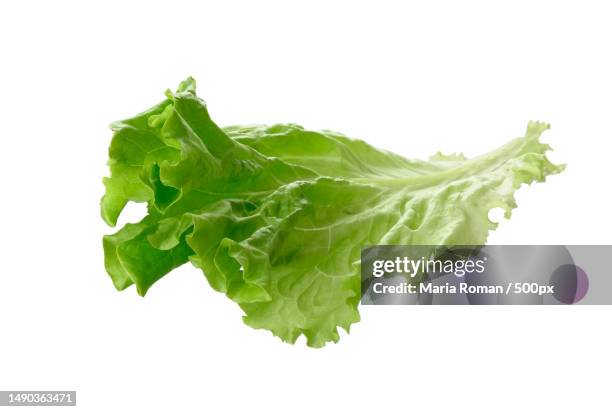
top-left (0, 0), bottom-right (612, 411)
